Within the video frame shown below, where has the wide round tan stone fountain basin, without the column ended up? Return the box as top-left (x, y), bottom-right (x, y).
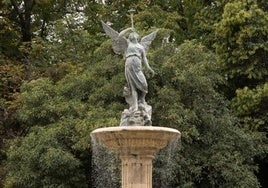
top-left (91, 126), bottom-right (180, 155)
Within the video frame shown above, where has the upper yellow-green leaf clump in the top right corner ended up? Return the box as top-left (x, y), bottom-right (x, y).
top-left (216, 1), bottom-right (268, 81)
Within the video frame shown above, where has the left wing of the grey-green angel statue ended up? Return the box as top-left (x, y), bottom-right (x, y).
top-left (101, 21), bottom-right (127, 54)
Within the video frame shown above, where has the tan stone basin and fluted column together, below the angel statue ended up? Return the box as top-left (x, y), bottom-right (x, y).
top-left (91, 126), bottom-right (180, 188)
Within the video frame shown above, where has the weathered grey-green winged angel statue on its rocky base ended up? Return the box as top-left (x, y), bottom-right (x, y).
top-left (101, 17), bottom-right (158, 126)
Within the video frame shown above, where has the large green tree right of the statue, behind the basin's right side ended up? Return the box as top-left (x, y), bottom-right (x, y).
top-left (152, 42), bottom-right (265, 187)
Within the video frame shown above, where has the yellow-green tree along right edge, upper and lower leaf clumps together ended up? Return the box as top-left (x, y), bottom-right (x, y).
top-left (215, 0), bottom-right (268, 186)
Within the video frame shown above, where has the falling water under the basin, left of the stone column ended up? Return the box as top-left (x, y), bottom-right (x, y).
top-left (92, 139), bottom-right (121, 188)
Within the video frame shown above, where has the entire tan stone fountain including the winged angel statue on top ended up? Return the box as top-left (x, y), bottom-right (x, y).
top-left (91, 14), bottom-right (180, 188)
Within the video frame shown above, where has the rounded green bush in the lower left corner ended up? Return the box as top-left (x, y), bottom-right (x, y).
top-left (5, 121), bottom-right (86, 187)
